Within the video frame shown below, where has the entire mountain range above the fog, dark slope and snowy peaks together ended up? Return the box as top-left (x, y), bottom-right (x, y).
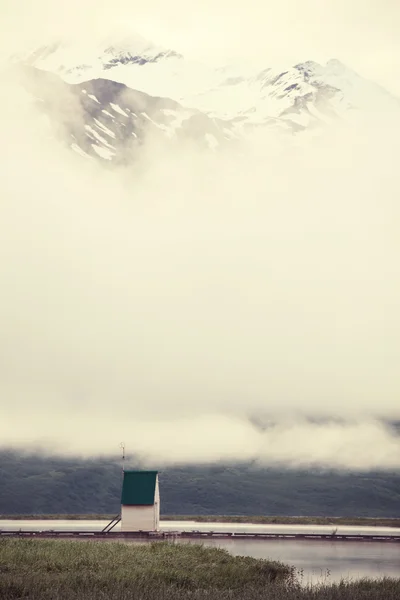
top-left (14, 35), bottom-right (400, 162)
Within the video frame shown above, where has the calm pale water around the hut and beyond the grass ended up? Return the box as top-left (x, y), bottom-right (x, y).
top-left (0, 521), bottom-right (400, 582)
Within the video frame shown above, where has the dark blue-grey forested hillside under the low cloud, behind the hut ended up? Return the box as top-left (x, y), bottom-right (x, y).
top-left (0, 451), bottom-right (400, 517)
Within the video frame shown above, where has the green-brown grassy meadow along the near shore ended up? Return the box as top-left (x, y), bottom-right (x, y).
top-left (0, 538), bottom-right (400, 600)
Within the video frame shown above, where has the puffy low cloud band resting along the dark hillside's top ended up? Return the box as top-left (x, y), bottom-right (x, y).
top-left (0, 412), bottom-right (400, 471)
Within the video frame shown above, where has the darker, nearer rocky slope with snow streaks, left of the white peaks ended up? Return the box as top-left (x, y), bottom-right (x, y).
top-left (22, 67), bottom-right (235, 164)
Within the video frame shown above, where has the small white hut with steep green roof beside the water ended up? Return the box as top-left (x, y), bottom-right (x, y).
top-left (121, 471), bottom-right (160, 532)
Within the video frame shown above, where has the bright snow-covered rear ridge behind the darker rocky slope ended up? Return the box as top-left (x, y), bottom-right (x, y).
top-left (24, 35), bottom-right (400, 131)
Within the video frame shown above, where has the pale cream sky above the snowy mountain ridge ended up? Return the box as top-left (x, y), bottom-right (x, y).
top-left (0, 0), bottom-right (400, 94)
